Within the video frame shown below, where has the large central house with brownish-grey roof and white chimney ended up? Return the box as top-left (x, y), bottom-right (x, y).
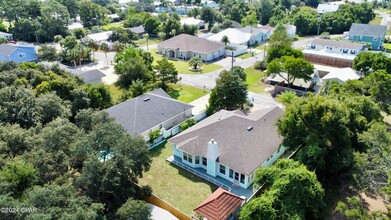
top-left (168, 107), bottom-right (285, 189)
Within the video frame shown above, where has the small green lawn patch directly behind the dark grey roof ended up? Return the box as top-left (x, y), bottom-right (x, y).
top-left (167, 84), bottom-right (209, 103)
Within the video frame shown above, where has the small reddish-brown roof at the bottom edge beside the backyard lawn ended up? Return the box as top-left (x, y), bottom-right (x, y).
top-left (194, 188), bottom-right (244, 220)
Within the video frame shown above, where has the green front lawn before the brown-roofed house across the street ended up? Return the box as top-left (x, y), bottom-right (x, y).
top-left (150, 49), bottom-right (223, 74)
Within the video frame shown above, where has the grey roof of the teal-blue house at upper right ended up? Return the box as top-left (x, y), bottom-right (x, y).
top-left (349, 23), bottom-right (387, 38)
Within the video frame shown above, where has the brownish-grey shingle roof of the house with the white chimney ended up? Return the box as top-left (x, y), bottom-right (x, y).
top-left (169, 107), bottom-right (283, 175)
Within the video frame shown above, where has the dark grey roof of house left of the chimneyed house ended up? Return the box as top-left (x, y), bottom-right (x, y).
top-left (105, 88), bottom-right (193, 135)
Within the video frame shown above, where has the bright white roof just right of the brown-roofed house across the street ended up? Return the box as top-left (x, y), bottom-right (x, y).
top-left (207, 28), bottom-right (251, 44)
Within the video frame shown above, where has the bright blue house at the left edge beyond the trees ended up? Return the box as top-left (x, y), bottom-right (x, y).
top-left (0, 44), bottom-right (38, 63)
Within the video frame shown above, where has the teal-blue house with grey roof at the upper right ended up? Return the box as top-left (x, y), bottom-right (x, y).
top-left (349, 24), bottom-right (387, 50)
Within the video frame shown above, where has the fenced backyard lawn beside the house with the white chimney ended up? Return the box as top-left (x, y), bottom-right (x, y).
top-left (139, 143), bottom-right (217, 215)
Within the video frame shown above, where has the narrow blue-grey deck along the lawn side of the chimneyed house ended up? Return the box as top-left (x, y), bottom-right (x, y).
top-left (167, 155), bottom-right (256, 199)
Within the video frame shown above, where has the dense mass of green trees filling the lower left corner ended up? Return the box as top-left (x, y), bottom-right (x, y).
top-left (0, 63), bottom-right (151, 219)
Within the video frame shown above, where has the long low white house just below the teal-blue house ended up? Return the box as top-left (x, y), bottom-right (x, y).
top-left (307, 38), bottom-right (365, 55)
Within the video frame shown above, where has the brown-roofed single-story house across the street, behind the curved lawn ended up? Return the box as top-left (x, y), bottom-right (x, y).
top-left (157, 34), bottom-right (225, 62)
